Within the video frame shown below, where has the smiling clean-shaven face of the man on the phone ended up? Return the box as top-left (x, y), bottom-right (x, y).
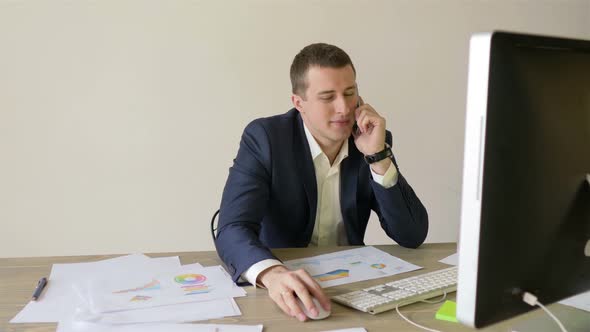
top-left (292, 65), bottom-right (358, 148)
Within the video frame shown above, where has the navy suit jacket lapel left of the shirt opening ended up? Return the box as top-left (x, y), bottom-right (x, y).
top-left (293, 115), bottom-right (318, 238)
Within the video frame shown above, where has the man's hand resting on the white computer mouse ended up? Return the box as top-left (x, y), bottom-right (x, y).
top-left (258, 265), bottom-right (331, 322)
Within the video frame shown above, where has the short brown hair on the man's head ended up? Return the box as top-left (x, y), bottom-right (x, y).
top-left (291, 43), bottom-right (356, 97)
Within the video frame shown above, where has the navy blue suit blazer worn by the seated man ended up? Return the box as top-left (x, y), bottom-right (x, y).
top-left (215, 109), bottom-right (428, 281)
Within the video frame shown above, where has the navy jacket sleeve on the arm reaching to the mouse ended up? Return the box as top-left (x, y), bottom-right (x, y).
top-left (215, 121), bottom-right (276, 281)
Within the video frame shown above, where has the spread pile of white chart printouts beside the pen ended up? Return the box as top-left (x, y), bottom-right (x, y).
top-left (11, 254), bottom-right (254, 332)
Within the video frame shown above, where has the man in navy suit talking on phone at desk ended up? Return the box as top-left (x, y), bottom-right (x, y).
top-left (215, 44), bottom-right (428, 321)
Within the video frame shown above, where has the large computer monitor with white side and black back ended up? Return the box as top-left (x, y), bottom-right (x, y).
top-left (457, 32), bottom-right (590, 327)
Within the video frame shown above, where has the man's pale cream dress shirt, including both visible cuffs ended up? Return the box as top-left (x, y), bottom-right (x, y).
top-left (242, 124), bottom-right (398, 287)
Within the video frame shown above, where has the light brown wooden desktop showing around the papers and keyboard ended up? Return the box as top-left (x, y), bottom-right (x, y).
top-left (0, 243), bottom-right (584, 332)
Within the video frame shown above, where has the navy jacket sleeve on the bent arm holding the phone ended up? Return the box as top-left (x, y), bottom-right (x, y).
top-left (371, 132), bottom-right (428, 248)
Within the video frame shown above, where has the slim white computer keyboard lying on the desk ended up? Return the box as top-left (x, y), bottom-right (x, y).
top-left (332, 266), bottom-right (457, 315)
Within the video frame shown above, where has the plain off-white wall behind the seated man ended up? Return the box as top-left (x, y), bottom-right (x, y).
top-left (0, 0), bottom-right (590, 257)
